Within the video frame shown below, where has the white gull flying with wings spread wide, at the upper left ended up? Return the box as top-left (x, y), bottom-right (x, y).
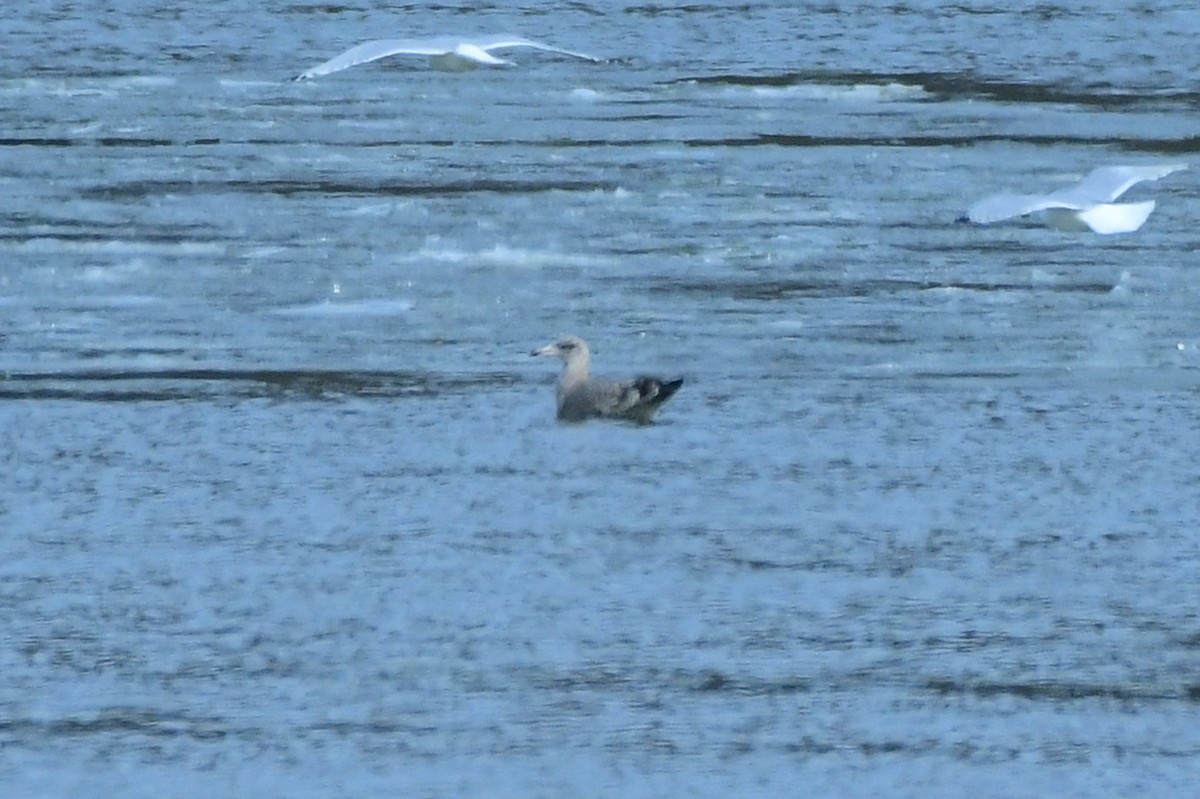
top-left (296, 35), bottom-right (604, 80)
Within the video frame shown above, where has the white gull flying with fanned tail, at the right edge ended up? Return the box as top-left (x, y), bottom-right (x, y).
top-left (964, 163), bottom-right (1188, 234)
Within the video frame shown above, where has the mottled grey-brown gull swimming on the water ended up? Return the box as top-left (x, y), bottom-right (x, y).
top-left (533, 336), bottom-right (683, 425)
